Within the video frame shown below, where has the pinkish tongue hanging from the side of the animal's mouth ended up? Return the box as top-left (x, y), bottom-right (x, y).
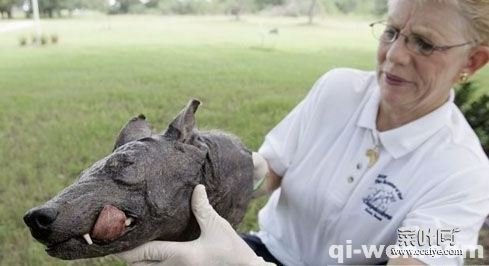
top-left (90, 205), bottom-right (126, 241)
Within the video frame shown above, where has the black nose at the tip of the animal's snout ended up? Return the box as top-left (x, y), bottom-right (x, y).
top-left (24, 207), bottom-right (58, 239)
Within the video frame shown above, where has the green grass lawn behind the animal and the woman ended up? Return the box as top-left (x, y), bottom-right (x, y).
top-left (0, 16), bottom-right (489, 265)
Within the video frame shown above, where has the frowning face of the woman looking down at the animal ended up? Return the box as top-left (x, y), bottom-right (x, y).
top-left (377, 0), bottom-right (470, 115)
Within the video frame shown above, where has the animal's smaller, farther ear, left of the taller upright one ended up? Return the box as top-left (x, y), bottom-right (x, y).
top-left (114, 114), bottom-right (151, 150)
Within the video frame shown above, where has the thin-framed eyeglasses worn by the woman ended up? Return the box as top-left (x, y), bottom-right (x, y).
top-left (369, 21), bottom-right (473, 56)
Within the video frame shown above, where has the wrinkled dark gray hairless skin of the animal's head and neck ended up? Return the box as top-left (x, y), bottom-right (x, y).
top-left (22, 100), bottom-right (253, 259)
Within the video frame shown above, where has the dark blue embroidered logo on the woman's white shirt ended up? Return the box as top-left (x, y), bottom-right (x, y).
top-left (363, 175), bottom-right (403, 221)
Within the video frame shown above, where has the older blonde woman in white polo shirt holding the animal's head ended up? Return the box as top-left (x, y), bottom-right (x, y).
top-left (118, 0), bottom-right (489, 265)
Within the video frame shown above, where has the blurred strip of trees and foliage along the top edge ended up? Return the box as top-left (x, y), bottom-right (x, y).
top-left (0, 0), bottom-right (387, 17)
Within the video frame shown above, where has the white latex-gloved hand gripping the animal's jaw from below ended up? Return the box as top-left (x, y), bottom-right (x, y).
top-left (117, 185), bottom-right (275, 266)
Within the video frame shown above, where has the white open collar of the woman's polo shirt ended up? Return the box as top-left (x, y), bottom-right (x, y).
top-left (357, 86), bottom-right (455, 159)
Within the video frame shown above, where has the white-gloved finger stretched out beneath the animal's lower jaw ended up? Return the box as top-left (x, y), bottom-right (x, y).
top-left (116, 241), bottom-right (189, 263)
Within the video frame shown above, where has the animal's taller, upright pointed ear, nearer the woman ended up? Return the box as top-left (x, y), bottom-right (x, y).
top-left (164, 99), bottom-right (200, 143)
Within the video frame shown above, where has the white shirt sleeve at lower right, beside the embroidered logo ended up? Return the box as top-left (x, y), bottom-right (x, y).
top-left (402, 167), bottom-right (489, 265)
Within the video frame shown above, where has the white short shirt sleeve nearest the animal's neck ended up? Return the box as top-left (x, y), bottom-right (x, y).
top-left (258, 72), bottom-right (329, 176)
